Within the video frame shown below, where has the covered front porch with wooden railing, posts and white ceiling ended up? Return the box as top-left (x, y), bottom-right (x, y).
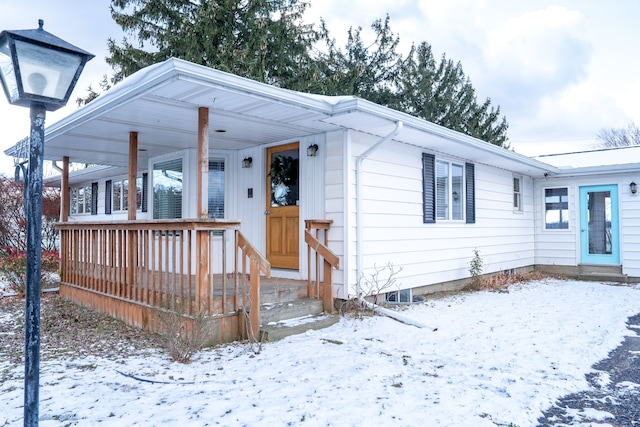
top-left (26, 59), bottom-right (340, 341)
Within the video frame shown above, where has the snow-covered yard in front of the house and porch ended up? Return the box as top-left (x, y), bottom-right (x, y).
top-left (0, 280), bottom-right (640, 427)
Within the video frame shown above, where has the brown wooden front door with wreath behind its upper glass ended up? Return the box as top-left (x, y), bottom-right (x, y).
top-left (265, 142), bottom-right (300, 270)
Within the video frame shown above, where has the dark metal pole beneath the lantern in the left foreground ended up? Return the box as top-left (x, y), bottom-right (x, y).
top-left (24, 102), bottom-right (46, 426)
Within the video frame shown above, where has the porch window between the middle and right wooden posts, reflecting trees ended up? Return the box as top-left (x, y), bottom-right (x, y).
top-left (153, 159), bottom-right (183, 219)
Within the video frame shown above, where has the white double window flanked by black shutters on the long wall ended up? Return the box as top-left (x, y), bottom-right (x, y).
top-left (422, 153), bottom-right (476, 224)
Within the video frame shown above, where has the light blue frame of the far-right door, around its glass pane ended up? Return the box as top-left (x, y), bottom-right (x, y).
top-left (579, 184), bottom-right (620, 265)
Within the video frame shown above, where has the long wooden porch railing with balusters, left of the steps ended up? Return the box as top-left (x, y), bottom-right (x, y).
top-left (57, 219), bottom-right (270, 339)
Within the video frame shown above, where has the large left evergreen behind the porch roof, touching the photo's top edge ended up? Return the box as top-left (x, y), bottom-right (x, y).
top-left (107, 0), bottom-right (319, 87)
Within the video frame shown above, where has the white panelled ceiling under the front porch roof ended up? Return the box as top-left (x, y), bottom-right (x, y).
top-left (25, 59), bottom-right (336, 168)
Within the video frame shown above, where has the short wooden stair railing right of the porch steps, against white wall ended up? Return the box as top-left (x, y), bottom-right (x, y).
top-left (304, 219), bottom-right (340, 313)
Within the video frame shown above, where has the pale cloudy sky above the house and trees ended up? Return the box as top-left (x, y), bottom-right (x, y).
top-left (0, 0), bottom-right (640, 174)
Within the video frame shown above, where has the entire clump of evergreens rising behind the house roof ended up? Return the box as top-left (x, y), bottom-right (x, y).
top-left (78, 0), bottom-right (508, 147)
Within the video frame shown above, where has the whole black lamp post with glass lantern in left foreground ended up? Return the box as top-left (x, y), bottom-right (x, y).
top-left (0, 20), bottom-right (93, 426)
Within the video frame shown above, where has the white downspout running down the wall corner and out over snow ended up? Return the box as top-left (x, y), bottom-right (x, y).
top-left (356, 120), bottom-right (436, 330)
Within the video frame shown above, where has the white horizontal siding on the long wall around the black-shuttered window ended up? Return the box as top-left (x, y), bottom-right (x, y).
top-left (347, 134), bottom-right (535, 293)
